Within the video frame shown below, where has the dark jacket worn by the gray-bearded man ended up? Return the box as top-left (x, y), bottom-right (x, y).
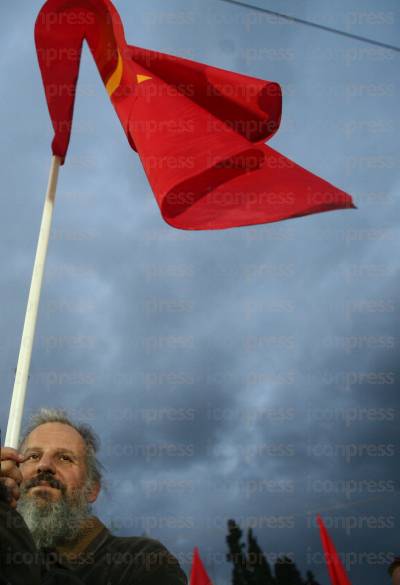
top-left (0, 488), bottom-right (187, 585)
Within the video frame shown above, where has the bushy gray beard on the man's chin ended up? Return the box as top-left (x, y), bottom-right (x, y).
top-left (17, 486), bottom-right (91, 548)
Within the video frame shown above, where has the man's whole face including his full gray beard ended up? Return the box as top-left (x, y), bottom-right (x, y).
top-left (17, 422), bottom-right (100, 548)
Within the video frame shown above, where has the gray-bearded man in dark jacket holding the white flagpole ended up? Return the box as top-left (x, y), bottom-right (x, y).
top-left (0, 409), bottom-right (187, 585)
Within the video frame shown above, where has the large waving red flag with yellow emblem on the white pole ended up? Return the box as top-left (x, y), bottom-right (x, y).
top-left (35, 0), bottom-right (354, 229)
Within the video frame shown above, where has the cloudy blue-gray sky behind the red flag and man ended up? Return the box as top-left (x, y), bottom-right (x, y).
top-left (0, 0), bottom-right (400, 585)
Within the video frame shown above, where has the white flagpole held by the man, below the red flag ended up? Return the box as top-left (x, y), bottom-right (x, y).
top-left (5, 156), bottom-right (61, 449)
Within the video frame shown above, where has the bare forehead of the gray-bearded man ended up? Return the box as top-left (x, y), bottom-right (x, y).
top-left (23, 422), bottom-right (85, 453)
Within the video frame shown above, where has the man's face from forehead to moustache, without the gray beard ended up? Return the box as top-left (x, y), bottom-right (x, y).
top-left (20, 422), bottom-right (97, 502)
